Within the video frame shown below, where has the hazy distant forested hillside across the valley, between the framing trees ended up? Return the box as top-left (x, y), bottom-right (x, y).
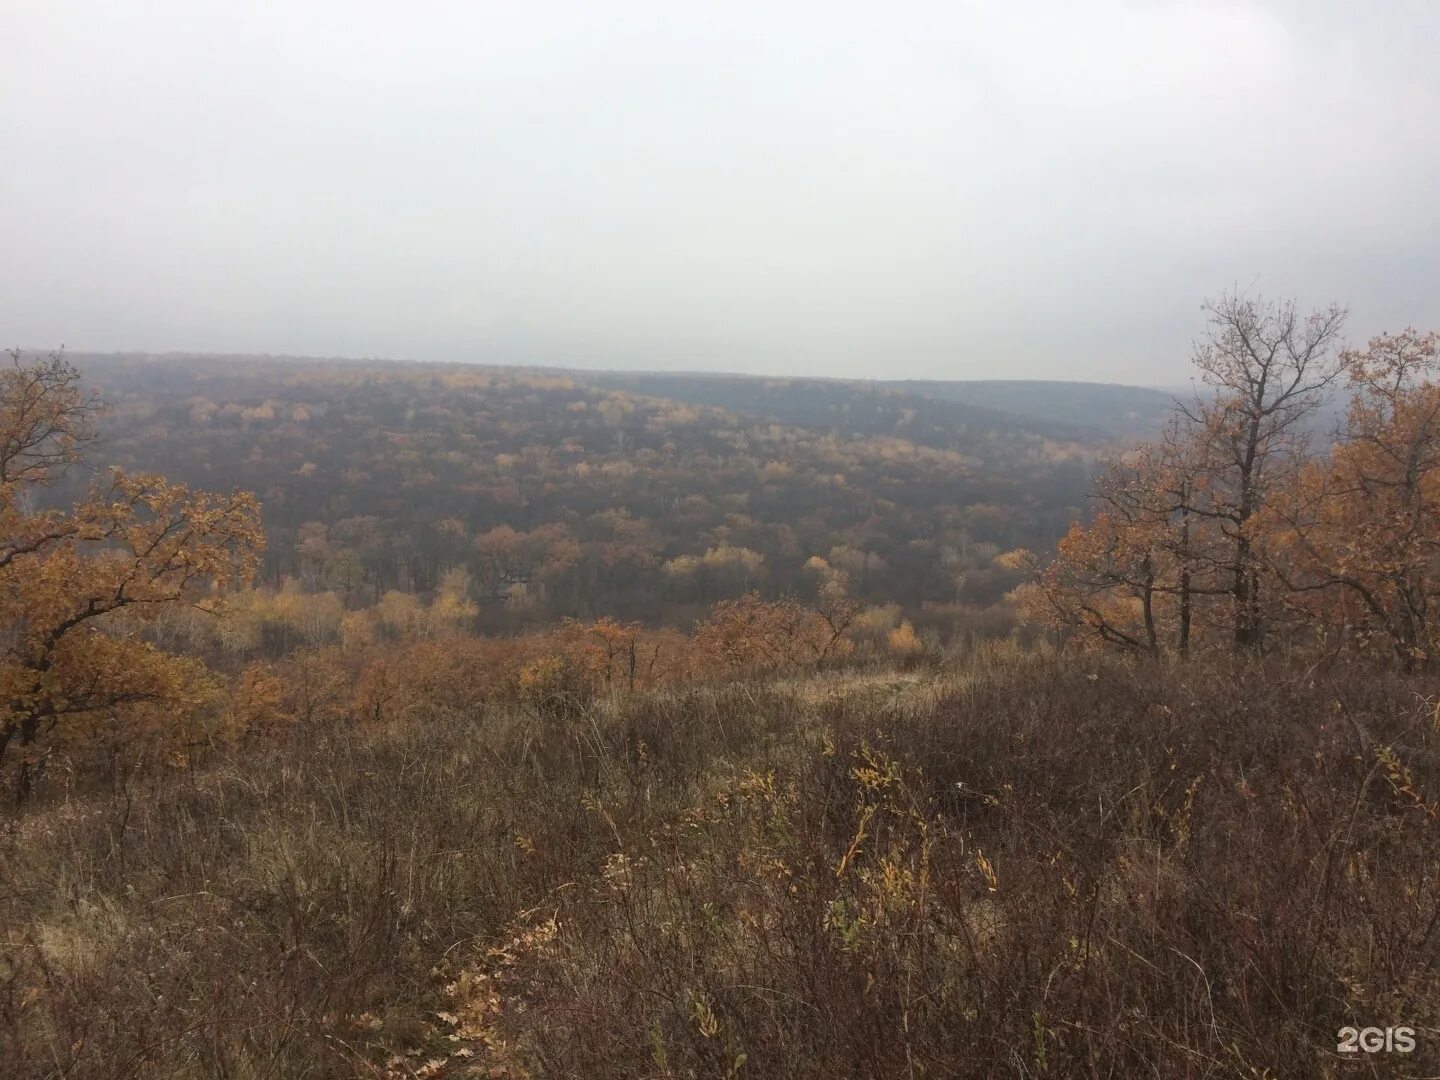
top-left (61, 357), bottom-right (1106, 636)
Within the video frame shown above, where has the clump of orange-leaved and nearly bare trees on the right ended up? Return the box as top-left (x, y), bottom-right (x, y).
top-left (1021, 295), bottom-right (1440, 670)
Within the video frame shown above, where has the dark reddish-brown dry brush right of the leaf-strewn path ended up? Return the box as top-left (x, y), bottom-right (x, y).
top-left (466, 660), bottom-right (1440, 1077)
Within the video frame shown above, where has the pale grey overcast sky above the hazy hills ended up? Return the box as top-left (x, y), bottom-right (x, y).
top-left (0, 0), bottom-right (1440, 384)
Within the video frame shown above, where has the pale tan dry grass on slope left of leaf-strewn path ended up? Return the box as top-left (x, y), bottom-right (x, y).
top-left (0, 688), bottom-right (798, 1080)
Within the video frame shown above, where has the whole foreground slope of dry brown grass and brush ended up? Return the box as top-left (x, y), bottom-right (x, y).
top-left (0, 655), bottom-right (1440, 1079)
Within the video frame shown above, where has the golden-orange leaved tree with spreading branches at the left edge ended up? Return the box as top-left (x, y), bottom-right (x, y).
top-left (0, 351), bottom-right (264, 798)
